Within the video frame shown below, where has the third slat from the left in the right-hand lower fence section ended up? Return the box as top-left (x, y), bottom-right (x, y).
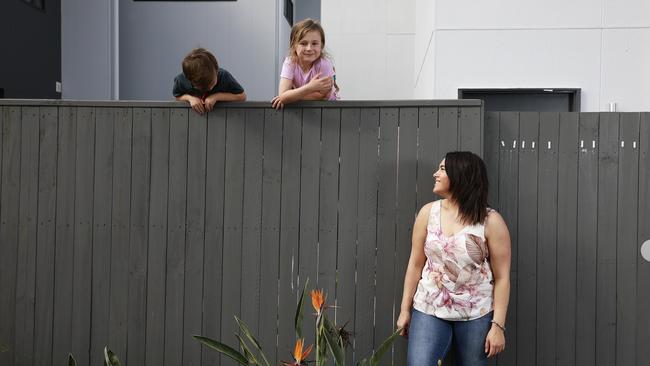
top-left (512, 112), bottom-right (539, 365)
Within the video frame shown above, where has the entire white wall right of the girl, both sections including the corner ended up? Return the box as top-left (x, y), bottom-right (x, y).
top-left (322, 0), bottom-right (650, 111)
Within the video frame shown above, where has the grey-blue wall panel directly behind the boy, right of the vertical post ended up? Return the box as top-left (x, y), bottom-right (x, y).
top-left (120, 0), bottom-right (278, 100)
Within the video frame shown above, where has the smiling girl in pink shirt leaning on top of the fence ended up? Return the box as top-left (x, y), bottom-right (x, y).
top-left (271, 19), bottom-right (338, 109)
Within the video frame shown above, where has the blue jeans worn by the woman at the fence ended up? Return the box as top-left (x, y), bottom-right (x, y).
top-left (407, 309), bottom-right (492, 366)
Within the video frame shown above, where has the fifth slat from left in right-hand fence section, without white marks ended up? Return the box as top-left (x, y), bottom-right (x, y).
top-left (542, 113), bottom-right (578, 366)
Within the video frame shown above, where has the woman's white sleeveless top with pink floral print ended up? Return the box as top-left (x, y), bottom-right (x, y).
top-left (413, 200), bottom-right (494, 320)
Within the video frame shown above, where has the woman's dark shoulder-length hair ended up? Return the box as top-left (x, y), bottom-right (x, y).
top-left (445, 151), bottom-right (488, 225)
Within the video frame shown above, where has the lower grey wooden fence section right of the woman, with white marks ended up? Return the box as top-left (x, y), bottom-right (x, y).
top-left (485, 112), bottom-right (650, 366)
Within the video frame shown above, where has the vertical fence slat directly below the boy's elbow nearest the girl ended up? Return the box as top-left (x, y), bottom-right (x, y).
top-left (221, 109), bottom-right (246, 365)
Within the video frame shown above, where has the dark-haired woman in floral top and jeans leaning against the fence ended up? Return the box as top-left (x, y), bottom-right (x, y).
top-left (397, 151), bottom-right (510, 366)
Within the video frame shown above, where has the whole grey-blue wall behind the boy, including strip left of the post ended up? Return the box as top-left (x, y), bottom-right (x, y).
top-left (61, 0), bottom-right (280, 100)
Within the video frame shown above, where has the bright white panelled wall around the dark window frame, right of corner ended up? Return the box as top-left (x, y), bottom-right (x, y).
top-left (416, 0), bottom-right (650, 111)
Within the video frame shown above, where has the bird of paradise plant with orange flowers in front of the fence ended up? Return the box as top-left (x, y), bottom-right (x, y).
top-left (192, 280), bottom-right (401, 366)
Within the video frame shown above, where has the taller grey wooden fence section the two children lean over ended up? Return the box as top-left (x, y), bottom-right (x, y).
top-left (0, 100), bottom-right (480, 366)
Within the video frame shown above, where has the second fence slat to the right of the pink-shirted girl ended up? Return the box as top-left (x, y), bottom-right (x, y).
top-left (354, 108), bottom-right (379, 361)
